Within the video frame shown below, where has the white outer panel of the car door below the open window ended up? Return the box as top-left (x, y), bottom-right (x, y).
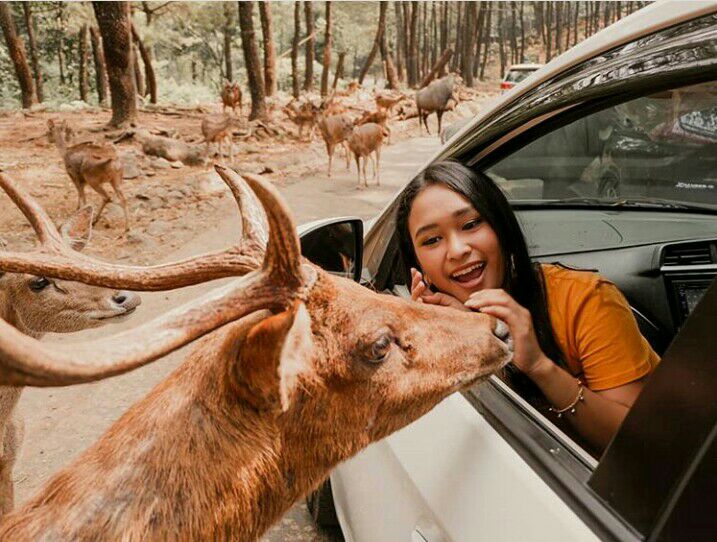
top-left (331, 394), bottom-right (598, 542)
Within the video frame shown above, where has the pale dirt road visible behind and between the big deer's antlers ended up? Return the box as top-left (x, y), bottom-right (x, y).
top-left (15, 137), bottom-right (439, 542)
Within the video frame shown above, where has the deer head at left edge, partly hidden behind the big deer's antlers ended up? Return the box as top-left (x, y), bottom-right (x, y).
top-left (0, 206), bottom-right (141, 336)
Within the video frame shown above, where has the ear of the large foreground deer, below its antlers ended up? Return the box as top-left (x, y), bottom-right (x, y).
top-left (238, 301), bottom-right (314, 412)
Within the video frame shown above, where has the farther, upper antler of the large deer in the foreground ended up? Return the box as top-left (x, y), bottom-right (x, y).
top-left (0, 166), bottom-right (267, 291)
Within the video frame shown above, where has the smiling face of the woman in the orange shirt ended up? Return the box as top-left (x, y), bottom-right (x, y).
top-left (408, 184), bottom-right (503, 302)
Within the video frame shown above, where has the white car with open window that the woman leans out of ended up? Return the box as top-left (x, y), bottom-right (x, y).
top-left (306, 1), bottom-right (717, 542)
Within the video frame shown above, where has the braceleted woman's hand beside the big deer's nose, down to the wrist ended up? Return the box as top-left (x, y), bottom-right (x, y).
top-left (465, 289), bottom-right (552, 376)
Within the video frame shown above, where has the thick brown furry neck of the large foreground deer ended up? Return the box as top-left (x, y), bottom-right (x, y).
top-left (0, 332), bottom-right (336, 540)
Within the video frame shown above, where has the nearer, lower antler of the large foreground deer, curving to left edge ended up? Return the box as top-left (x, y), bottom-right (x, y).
top-left (0, 168), bottom-right (302, 386)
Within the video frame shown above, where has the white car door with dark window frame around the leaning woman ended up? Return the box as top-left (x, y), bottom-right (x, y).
top-left (331, 15), bottom-right (717, 542)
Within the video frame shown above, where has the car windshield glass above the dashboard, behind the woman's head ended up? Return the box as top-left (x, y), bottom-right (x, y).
top-left (487, 82), bottom-right (717, 210)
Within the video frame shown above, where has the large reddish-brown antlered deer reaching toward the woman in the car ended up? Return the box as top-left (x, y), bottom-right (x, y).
top-left (0, 165), bottom-right (512, 541)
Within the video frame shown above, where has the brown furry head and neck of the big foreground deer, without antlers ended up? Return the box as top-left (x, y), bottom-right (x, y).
top-left (0, 169), bottom-right (510, 541)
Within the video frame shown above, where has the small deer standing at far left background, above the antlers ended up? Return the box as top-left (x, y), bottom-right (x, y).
top-left (47, 119), bottom-right (129, 232)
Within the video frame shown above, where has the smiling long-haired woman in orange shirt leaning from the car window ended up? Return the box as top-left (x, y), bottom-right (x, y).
top-left (397, 161), bottom-right (659, 450)
